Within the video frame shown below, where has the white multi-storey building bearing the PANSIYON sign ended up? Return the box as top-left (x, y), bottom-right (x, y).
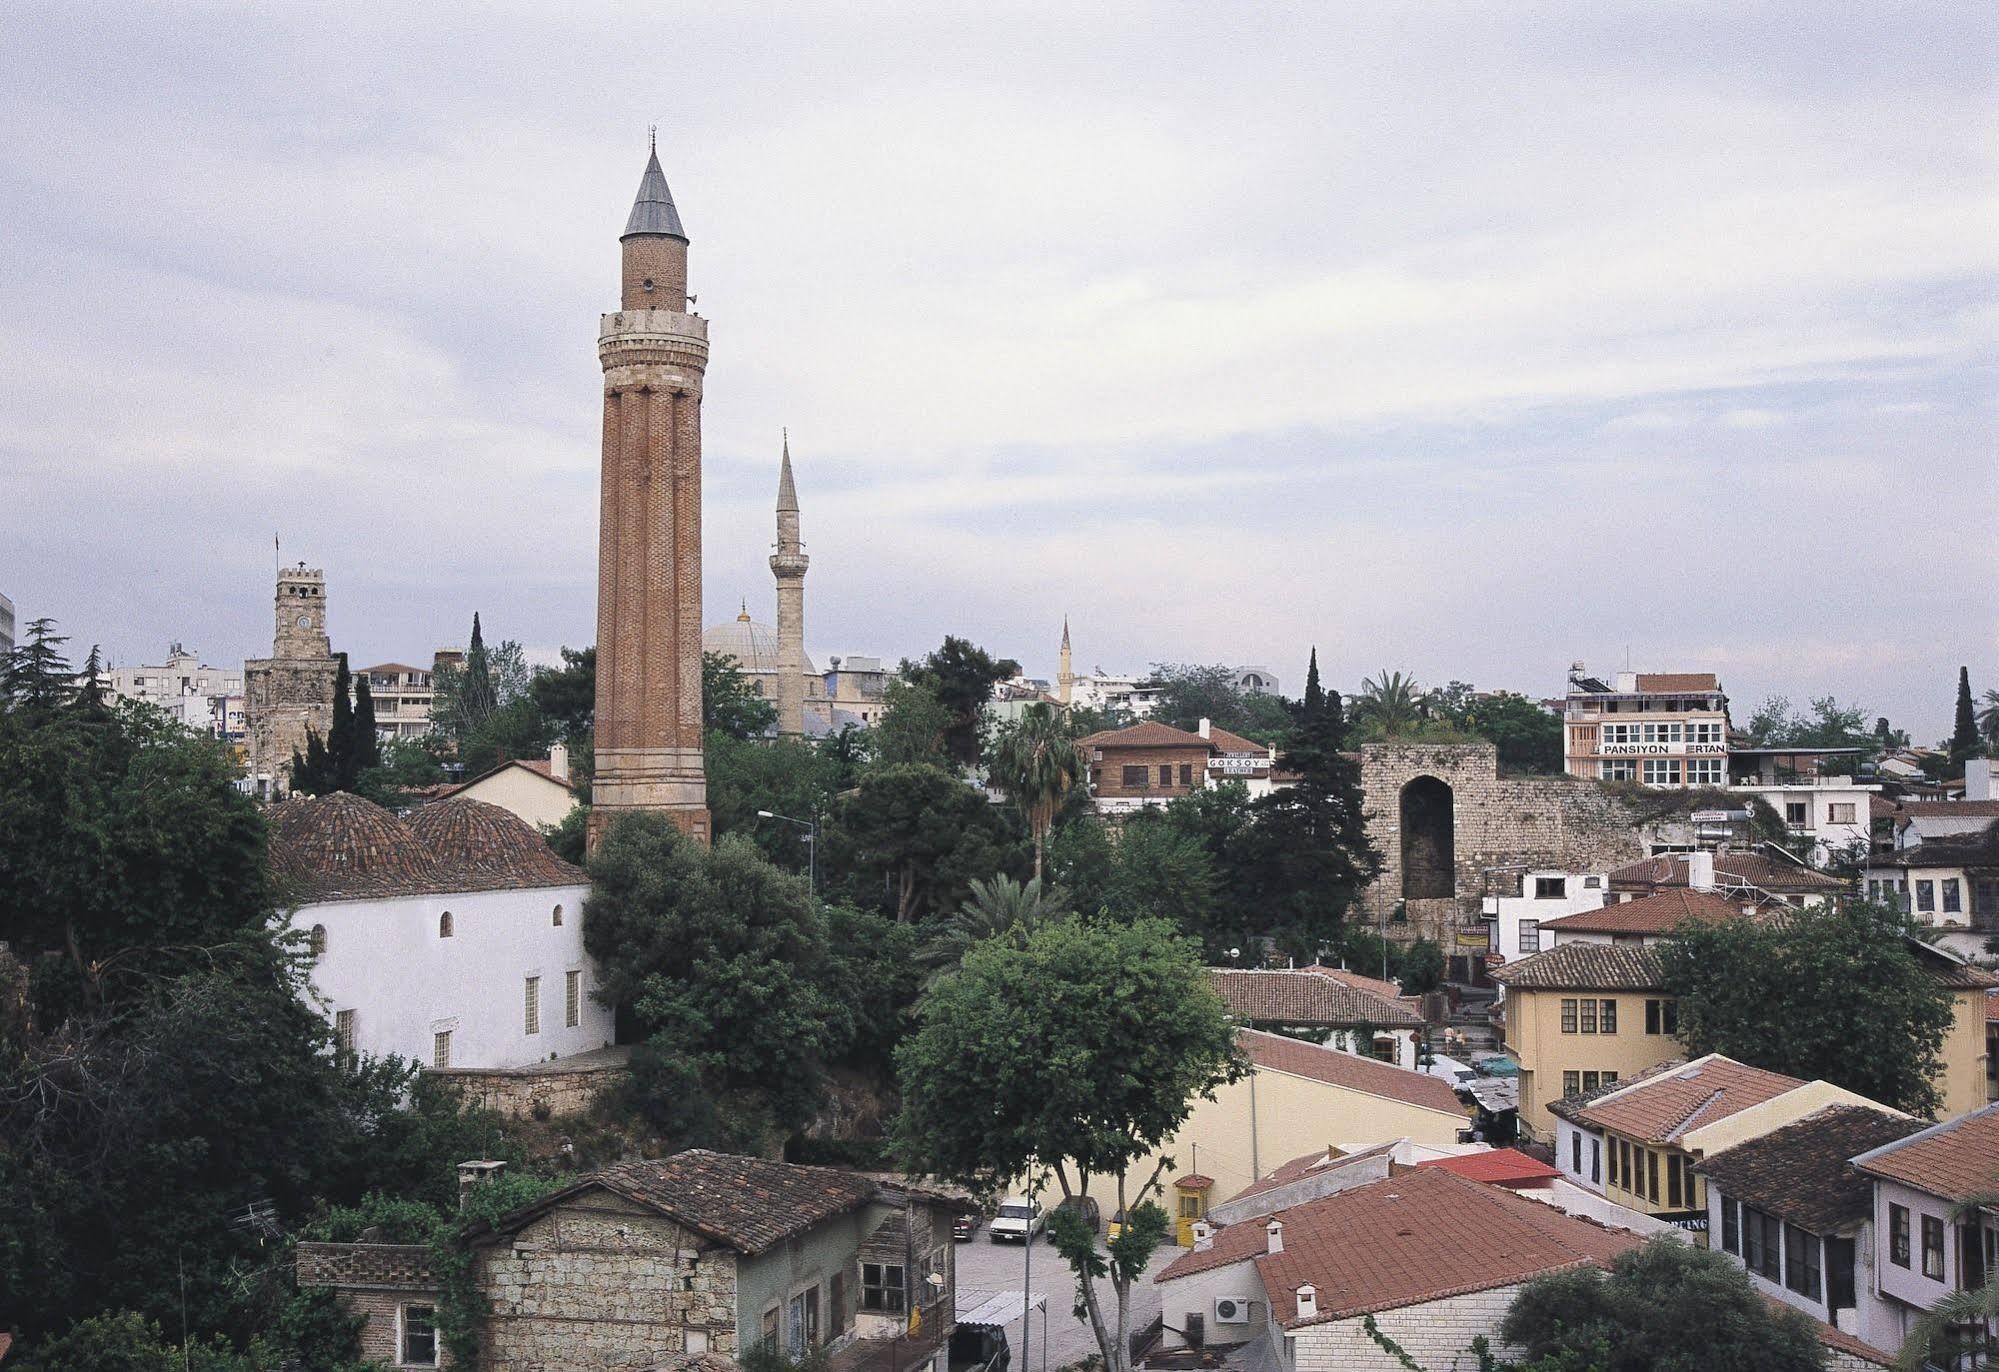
top-left (1563, 662), bottom-right (1729, 786)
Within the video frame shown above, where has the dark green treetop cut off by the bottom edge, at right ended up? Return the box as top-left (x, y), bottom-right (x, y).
top-left (1501, 1238), bottom-right (1825, 1372)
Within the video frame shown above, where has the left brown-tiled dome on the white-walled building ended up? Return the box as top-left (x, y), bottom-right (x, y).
top-left (270, 790), bottom-right (436, 900)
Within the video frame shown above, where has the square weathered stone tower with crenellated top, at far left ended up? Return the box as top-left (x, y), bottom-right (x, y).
top-left (244, 562), bottom-right (340, 800)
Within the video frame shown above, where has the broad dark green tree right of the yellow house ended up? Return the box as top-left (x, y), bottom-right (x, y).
top-left (1659, 900), bottom-right (1951, 1114)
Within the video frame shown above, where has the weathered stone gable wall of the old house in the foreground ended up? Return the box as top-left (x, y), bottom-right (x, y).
top-left (474, 1192), bottom-right (736, 1372)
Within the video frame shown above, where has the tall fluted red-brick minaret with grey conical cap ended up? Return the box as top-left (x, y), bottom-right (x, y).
top-left (590, 150), bottom-right (708, 848)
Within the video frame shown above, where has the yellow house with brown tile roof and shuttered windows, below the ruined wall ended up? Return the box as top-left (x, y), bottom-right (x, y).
top-left (1491, 944), bottom-right (1681, 1144)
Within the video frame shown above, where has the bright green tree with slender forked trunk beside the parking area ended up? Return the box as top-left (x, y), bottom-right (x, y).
top-left (896, 916), bottom-right (1243, 1372)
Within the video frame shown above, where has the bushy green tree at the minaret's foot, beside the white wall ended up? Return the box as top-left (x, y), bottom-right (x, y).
top-left (584, 814), bottom-right (854, 1152)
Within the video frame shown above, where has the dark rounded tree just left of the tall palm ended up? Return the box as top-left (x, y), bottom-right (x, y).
top-left (826, 762), bottom-right (1029, 924)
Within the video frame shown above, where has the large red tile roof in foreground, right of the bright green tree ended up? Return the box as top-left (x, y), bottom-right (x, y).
top-left (1155, 1168), bottom-right (1643, 1328)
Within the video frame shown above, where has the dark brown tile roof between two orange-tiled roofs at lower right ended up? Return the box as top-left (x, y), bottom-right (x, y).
top-left (1695, 1106), bottom-right (1923, 1236)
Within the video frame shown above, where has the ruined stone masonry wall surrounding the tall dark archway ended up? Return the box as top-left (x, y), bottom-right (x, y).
top-left (1359, 744), bottom-right (1645, 944)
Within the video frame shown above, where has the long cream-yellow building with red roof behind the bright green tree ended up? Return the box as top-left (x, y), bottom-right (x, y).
top-left (1089, 1030), bottom-right (1471, 1220)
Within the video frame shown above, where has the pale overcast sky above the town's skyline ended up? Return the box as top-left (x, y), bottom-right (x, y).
top-left (0, 0), bottom-right (1999, 738)
